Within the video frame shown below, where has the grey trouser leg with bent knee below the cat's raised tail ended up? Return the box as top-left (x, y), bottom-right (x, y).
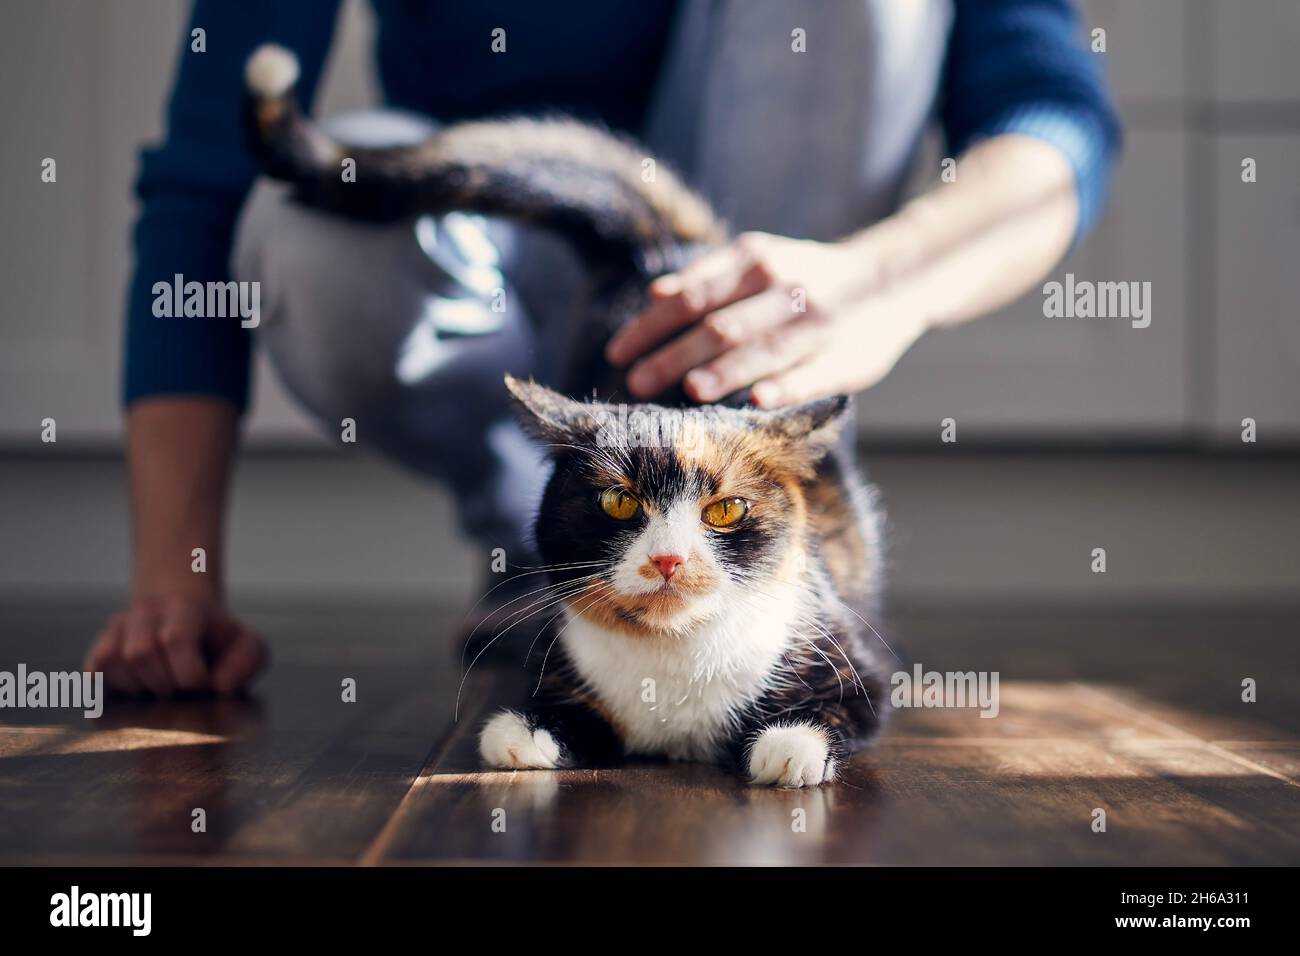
top-left (231, 112), bottom-right (582, 564)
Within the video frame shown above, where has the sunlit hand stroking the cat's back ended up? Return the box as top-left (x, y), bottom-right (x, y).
top-left (606, 233), bottom-right (926, 407)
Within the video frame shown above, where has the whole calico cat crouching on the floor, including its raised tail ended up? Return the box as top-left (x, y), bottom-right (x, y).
top-left (246, 48), bottom-right (888, 787)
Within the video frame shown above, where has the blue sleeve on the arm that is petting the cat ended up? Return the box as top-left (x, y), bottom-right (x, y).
top-left (943, 0), bottom-right (1122, 242)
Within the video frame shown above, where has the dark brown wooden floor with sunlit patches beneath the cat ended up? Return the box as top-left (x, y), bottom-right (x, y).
top-left (0, 607), bottom-right (1300, 865)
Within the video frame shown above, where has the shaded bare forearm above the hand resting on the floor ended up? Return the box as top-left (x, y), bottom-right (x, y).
top-left (127, 397), bottom-right (238, 598)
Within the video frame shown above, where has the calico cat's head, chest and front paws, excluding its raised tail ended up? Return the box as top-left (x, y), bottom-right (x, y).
top-left (480, 378), bottom-right (888, 787)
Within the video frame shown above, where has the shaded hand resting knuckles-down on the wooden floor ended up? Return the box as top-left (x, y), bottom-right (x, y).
top-left (83, 593), bottom-right (267, 697)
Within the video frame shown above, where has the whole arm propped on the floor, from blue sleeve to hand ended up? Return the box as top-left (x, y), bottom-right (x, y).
top-left (86, 0), bottom-right (337, 696)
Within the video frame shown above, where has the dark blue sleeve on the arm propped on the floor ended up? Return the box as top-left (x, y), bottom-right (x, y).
top-left (122, 0), bottom-right (338, 410)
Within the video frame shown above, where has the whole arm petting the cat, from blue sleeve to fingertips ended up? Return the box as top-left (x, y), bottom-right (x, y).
top-left (608, 0), bottom-right (1118, 405)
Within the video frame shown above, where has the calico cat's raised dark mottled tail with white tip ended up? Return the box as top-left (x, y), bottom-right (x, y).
top-left (244, 46), bottom-right (724, 272)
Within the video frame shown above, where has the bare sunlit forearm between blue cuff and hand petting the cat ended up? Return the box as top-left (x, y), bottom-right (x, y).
top-left (846, 134), bottom-right (1079, 328)
